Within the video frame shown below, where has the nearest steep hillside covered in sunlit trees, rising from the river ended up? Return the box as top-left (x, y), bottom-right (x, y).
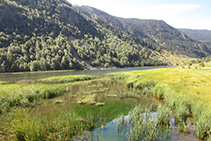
top-left (0, 0), bottom-right (167, 72)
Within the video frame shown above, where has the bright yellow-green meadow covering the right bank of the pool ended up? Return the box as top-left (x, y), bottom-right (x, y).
top-left (109, 68), bottom-right (211, 139)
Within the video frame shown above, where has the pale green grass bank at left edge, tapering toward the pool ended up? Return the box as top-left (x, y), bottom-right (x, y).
top-left (0, 84), bottom-right (65, 113)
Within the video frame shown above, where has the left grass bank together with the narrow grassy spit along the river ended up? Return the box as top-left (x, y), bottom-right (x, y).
top-left (0, 75), bottom-right (97, 113)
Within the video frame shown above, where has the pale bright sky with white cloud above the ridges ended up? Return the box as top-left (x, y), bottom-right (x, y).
top-left (68, 0), bottom-right (211, 30)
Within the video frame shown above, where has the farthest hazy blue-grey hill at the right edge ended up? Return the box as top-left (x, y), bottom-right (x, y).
top-left (179, 29), bottom-right (211, 50)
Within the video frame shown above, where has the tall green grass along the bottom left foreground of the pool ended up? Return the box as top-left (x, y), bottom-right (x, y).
top-left (8, 110), bottom-right (94, 141)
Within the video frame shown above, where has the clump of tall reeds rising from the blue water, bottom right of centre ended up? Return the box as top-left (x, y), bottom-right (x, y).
top-left (123, 104), bottom-right (171, 140)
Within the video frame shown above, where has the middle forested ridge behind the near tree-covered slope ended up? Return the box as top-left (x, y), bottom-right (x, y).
top-left (75, 6), bottom-right (211, 57)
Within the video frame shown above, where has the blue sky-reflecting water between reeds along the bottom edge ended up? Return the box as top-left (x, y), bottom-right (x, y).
top-left (73, 112), bottom-right (199, 141)
